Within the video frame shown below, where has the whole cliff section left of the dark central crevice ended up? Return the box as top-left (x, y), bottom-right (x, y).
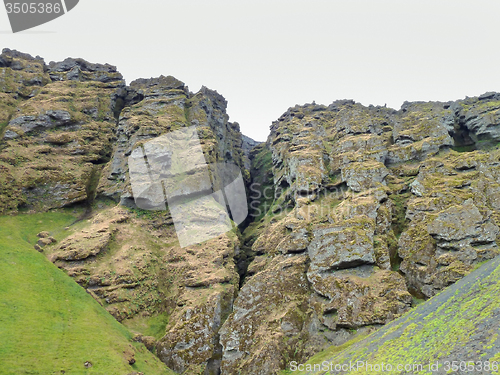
top-left (0, 50), bottom-right (252, 373)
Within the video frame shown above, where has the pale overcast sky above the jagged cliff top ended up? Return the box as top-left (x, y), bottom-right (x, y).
top-left (0, 0), bottom-right (500, 141)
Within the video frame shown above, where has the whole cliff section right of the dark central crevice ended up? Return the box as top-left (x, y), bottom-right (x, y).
top-left (221, 98), bottom-right (500, 374)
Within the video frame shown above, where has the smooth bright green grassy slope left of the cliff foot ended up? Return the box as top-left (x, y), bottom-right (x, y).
top-left (0, 213), bottom-right (171, 375)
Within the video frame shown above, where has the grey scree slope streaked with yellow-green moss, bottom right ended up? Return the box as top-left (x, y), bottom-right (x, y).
top-left (284, 257), bottom-right (500, 374)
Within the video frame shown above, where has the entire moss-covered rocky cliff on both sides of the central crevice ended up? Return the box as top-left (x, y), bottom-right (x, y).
top-left (0, 49), bottom-right (500, 374)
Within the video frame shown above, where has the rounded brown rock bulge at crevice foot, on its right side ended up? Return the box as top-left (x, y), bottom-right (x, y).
top-left (221, 255), bottom-right (309, 374)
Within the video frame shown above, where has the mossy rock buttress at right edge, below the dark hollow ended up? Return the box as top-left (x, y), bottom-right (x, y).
top-left (399, 151), bottom-right (500, 297)
